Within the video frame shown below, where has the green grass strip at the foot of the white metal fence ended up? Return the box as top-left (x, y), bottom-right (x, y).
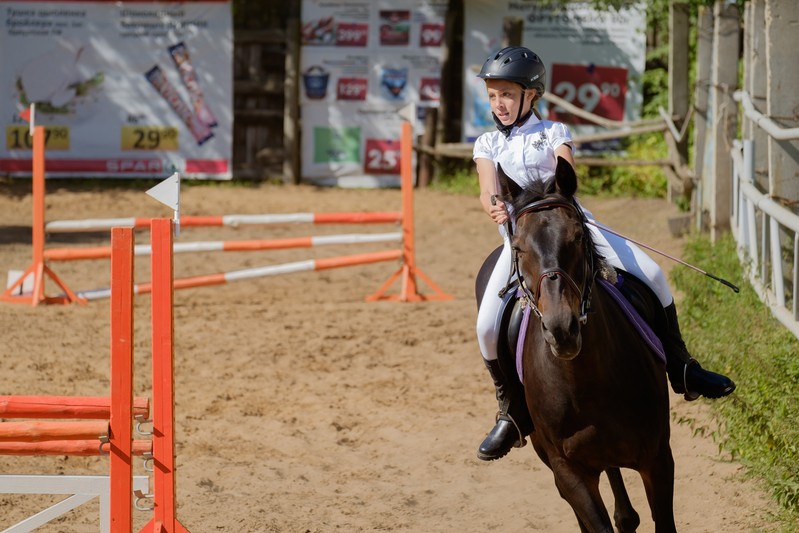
top-left (673, 235), bottom-right (799, 532)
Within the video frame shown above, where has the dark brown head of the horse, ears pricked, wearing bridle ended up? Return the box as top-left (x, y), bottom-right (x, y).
top-left (498, 157), bottom-right (595, 359)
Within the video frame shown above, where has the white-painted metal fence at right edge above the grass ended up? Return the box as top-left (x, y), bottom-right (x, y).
top-left (730, 91), bottom-right (799, 338)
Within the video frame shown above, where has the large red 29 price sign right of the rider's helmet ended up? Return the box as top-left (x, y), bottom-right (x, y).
top-left (549, 64), bottom-right (627, 124)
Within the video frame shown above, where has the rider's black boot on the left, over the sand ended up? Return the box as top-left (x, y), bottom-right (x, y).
top-left (477, 359), bottom-right (533, 461)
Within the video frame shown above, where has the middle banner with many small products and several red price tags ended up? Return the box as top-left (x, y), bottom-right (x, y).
top-left (300, 0), bottom-right (448, 187)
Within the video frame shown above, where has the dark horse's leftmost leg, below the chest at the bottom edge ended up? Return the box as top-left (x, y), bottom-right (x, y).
top-left (551, 457), bottom-right (613, 533)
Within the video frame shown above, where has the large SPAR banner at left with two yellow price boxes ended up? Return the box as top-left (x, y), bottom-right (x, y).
top-left (0, 0), bottom-right (233, 179)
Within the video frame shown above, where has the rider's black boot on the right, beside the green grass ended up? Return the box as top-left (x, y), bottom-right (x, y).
top-left (661, 302), bottom-right (735, 401)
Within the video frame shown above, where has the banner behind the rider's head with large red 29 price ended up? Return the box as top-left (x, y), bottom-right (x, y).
top-left (463, 0), bottom-right (646, 142)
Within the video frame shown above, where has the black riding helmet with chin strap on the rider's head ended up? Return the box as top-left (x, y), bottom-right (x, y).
top-left (477, 46), bottom-right (547, 137)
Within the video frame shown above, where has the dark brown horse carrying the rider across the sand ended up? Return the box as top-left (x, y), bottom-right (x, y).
top-left (478, 158), bottom-right (675, 533)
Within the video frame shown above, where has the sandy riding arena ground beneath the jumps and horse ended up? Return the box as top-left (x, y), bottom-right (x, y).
top-left (0, 181), bottom-right (773, 533)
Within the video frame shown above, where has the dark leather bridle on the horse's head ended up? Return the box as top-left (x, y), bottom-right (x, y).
top-left (513, 198), bottom-right (596, 324)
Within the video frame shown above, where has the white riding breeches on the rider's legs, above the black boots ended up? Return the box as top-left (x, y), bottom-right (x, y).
top-left (477, 210), bottom-right (673, 361)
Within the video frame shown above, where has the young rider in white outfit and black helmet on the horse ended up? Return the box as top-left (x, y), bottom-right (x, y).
top-left (474, 47), bottom-right (735, 461)
